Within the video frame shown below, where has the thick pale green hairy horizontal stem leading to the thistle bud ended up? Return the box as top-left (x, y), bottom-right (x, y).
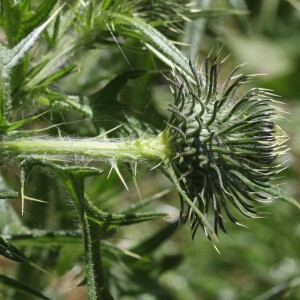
top-left (0, 134), bottom-right (168, 161)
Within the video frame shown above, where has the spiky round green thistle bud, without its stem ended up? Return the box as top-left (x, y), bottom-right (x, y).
top-left (167, 58), bottom-right (286, 237)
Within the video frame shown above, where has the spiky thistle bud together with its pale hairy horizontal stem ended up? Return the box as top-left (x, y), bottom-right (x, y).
top-left (0, 58), bottom-right (286, 238)
